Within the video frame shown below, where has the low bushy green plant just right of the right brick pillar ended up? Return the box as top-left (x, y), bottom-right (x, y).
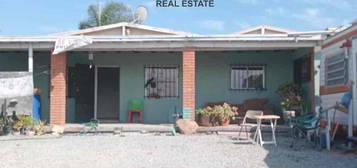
top-left (196, 103), bottom-right (238, 126)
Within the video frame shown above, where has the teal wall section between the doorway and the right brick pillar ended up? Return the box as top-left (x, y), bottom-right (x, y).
top-left (94, 52), bottom-right (182, 123)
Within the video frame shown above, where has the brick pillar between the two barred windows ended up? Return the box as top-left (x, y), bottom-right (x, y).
top-left (182, 48), bottom-right (196, 120)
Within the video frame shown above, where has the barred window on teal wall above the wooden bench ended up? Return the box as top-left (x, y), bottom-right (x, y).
top-left (231, 65), bottom-right (265, 90)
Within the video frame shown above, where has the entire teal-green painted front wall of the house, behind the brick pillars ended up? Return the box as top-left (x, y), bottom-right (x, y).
top-left (0, 49), bottom-right (309, 123)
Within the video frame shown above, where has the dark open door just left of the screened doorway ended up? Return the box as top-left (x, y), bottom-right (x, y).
top-left (74, 64), bottom-right (94, 123)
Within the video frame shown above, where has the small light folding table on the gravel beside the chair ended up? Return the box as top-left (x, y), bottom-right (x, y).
top-left (254, 115), bottom-right (280, 146)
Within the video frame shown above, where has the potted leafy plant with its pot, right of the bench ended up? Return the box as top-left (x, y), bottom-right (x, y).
top-left (276, 83), bottom-right (303, 122)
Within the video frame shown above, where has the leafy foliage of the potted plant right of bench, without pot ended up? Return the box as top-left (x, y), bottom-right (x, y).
top-left (276, 83), bottom-right (302, 110)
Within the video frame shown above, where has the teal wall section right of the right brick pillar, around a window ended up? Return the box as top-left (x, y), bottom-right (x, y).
top-left (196, 51), bottom-right (294, 112)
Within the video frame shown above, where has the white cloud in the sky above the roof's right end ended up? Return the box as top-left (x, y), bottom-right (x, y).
top-left (292, 8), bottom-right (337, 28)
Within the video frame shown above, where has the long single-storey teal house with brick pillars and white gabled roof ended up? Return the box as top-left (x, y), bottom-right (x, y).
top-left (0, 23), bottom-right (322, 124)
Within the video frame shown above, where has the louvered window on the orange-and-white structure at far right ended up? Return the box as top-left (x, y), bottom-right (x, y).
top-left (325, 53), bottom-right (348, 87)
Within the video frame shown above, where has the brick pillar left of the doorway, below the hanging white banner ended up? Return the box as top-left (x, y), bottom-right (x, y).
top-left (50, 53), bottom-right (67, 125)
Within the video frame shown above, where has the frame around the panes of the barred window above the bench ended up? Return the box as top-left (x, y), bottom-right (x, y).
top-left (229, 64), bottom-right (267, 91)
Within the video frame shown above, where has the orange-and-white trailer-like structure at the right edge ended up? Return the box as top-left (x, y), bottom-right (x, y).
top-left (320, 21), bottom-right (357, 137)
